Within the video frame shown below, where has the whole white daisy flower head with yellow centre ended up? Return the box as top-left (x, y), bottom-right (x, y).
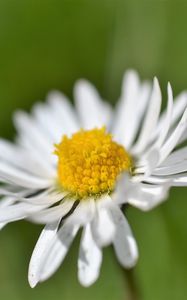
top-left (0, 71), bottom-right (187, 287)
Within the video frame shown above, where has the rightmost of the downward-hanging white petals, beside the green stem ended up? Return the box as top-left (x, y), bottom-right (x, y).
top-left (111, 204), bottom-right (138, 268)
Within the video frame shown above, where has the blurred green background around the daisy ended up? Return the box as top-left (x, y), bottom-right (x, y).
top-left (0, 0), bottom-right (187, 300)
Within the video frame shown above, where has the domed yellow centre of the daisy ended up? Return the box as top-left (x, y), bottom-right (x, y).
top-left (55, 128), bottom-right (132, 198)
